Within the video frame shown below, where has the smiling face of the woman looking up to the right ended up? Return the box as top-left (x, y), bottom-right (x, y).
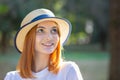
top-left (35, 21), bottom-right (59, 54)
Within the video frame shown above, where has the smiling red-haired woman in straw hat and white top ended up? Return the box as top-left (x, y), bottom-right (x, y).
top-left (4, 9), bottom-right (83, 80)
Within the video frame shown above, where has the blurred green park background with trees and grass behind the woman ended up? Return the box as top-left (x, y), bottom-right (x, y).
top-left (0, 0), bottom-right (120, 80)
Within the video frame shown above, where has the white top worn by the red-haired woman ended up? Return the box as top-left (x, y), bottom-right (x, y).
top-left (4, 62), bottom-right (83, 80)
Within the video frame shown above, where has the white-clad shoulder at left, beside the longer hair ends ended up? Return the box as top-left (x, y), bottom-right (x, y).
top-left (4, 71), bottom-right (20, 80)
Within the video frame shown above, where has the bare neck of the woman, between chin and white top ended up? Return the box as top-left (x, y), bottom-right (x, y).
top-left (33, 54), bottom-right (50, 72)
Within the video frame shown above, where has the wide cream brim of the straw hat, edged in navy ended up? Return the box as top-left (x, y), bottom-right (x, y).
top-left (15, 17), bottom-right (72, 53)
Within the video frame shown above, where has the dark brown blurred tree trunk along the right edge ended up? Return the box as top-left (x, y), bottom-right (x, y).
top-left (109, 0), bottom-right (120, 80)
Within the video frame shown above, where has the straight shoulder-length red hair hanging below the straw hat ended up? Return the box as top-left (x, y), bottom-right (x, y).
top-left (16, 23), bottom-right (61, 78)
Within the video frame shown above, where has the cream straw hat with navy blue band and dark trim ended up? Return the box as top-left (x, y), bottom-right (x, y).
top-left (15, 9), bottom-right (72, 52)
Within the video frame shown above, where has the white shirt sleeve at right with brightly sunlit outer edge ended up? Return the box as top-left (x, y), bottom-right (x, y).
top-left (67, 62), bottom-right (83, 80)
